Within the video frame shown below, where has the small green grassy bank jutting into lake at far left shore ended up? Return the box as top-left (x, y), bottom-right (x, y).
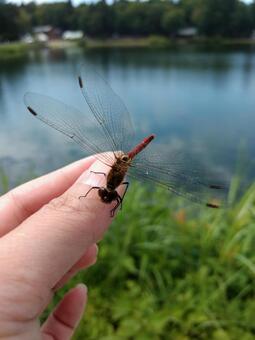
top-left (0, 42), bottom-right (28, 62)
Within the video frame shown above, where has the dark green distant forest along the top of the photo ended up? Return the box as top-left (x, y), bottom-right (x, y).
top-left (0, 0), bottom-right (255, 41)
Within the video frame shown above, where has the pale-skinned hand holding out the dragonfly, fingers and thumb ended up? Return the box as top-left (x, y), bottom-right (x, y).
top-left (0, 157), bottom-right (121, 340)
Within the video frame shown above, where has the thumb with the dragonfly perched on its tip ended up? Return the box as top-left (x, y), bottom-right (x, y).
top-left (0, 157), bottom-right (123, 298)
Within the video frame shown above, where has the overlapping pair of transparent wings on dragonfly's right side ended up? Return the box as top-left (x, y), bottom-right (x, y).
top-left (129, 146), bottom-right (228, 208)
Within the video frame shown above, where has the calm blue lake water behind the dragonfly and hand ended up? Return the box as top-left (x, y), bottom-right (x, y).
top-left (0, 49), bottom-right (255, 191)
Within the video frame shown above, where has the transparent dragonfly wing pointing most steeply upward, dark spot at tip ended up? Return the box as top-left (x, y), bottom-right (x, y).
top-left (79, 65), bottom-right (134, 152)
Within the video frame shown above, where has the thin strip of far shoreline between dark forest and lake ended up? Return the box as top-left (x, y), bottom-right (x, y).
top-left (0, 35), bottom-right (255, 62)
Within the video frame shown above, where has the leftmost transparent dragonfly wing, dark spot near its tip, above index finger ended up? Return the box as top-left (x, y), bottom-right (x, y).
top-left (24, 92), bottom-right (114, 165)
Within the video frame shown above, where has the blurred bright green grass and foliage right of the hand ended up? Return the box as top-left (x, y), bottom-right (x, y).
top-left (45, 183), bottom-right (255, 340)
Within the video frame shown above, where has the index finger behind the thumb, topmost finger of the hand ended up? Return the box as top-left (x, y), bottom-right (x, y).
top-left (0, 156), bottom-right (95, 237)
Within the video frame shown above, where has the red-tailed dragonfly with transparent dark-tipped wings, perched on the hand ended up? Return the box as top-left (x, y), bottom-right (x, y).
top-left (24, 65), bottom-right (226, 217)
